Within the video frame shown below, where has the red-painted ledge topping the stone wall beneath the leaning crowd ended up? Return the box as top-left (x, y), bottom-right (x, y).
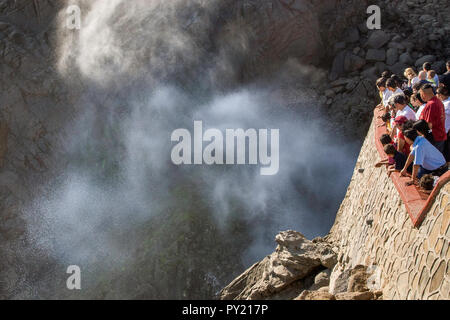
top-left (373, 109), bottom-right (450, 228)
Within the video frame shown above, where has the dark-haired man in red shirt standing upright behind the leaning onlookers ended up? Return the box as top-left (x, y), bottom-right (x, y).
top-left (420, 84), bottom-right (447, 152)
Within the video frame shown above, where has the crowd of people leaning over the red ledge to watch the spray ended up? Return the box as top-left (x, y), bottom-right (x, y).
top-left (376, 61), bottom-right (450, 192)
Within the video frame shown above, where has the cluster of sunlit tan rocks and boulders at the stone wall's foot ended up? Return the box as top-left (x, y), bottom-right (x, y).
top-left (219, 231), bottom-right (382, 300)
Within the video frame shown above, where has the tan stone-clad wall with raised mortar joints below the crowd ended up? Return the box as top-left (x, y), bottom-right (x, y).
top-left (326, 117), bottom-right (450, 299)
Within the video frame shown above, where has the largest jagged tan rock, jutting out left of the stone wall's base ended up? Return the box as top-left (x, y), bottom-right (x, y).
top-left (220, 230), bottom-right (337, 300)
